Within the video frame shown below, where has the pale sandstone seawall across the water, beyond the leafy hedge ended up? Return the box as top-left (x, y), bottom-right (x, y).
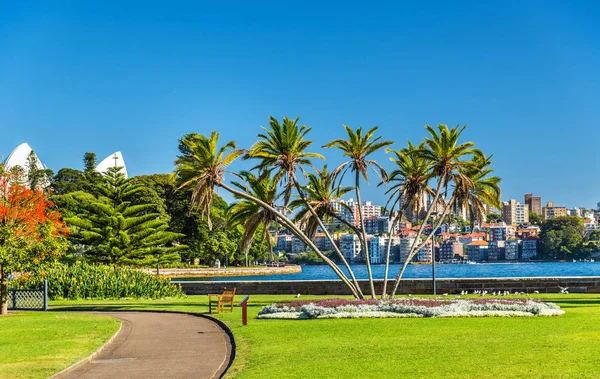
top-left (141, 265), bottom-right (302, 278)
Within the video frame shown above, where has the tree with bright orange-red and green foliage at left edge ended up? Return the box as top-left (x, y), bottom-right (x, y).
top-left (0, 171), bottom-right (68, 315)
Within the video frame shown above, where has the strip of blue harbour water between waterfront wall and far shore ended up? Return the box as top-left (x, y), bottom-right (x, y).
top-left (176, 262), bottom-right (600, 281)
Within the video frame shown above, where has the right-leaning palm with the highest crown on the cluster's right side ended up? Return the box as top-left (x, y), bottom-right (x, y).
top-left (392, 124), bottom-right (485, 297)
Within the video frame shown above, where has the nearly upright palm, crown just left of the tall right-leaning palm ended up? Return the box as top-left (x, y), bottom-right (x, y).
top-left (382, 141), bottom-right (434, 298)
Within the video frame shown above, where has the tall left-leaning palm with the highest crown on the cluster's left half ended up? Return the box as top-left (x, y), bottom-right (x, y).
top-left (246, 116), bottom-right (360, 296)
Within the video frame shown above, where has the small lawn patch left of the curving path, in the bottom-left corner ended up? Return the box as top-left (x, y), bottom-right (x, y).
top-left (0, 312), bottom-right (120, 378)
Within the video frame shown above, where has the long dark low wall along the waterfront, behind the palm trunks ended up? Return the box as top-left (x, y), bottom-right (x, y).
top-left (181, 276), bottom-right (600, 295)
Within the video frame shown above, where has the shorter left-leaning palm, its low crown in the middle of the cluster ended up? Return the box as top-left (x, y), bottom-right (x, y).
top-left (290, 165), bottom-right (362, 296)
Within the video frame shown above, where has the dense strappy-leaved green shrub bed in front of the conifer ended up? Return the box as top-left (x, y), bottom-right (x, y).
top-left (10, 263), bottom-right (183, 300)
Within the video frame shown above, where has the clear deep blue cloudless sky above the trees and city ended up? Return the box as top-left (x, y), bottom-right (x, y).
top-left (0, 0), bottom-right (600, 207)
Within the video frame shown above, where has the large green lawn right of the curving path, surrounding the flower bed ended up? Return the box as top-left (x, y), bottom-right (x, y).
top-left (53, 295), bottom-right (600, 378)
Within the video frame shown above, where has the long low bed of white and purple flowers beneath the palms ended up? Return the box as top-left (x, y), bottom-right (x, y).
top-left (258, 298), bottom-right (565, 320)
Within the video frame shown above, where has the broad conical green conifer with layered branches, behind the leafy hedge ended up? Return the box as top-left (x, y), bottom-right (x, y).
top-left (66, 167), bottom-right (186, 266)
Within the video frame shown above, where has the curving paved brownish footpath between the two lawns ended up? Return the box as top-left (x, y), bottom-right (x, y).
top-left (61, 312), bottom-right (231, 379)
